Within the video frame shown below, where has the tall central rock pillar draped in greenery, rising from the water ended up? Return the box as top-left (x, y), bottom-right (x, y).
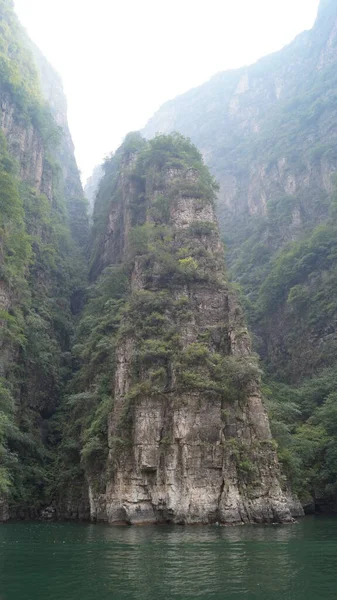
top-left (63, 136), bottom-right (301, 523)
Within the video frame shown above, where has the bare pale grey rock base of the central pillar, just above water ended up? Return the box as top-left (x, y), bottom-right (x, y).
top-left (100, 394), bottom-right (291, 523)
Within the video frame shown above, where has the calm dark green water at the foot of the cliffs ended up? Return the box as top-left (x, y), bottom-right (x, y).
top-left (0, 518), bottom-right (337, 600)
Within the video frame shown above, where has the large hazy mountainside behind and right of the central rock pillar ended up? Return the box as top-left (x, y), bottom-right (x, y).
top-left (140, 0), bottom-right (337, 508)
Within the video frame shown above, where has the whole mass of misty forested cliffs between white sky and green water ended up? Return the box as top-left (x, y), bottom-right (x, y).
top-left (0, 0), bottom-right (337, 524)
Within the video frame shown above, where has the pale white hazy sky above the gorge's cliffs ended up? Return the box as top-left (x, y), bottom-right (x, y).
top-left (14, 0), bottom-right (319, 179)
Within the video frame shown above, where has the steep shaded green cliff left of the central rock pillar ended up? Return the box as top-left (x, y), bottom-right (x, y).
top-left (0, 0), bottom-right (88, 520)
